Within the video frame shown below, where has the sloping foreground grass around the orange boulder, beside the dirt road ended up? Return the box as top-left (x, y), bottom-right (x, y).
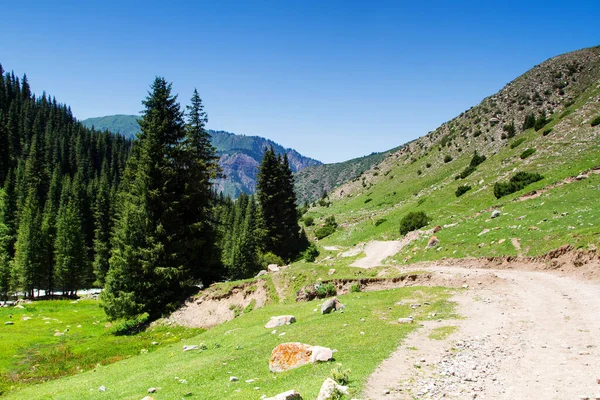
top-left (6, 287), bottom-right (456, 400)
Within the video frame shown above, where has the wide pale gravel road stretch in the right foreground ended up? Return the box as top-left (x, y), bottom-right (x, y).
top-left (364, 267), bottom-right (600, 400)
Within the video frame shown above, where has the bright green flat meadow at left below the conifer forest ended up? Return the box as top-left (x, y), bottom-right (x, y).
top-left (0, 300), bottom-right (202, 393)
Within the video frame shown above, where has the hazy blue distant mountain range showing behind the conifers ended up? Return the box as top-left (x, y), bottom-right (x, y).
top-left (81, 115), bottom-right (321, 198)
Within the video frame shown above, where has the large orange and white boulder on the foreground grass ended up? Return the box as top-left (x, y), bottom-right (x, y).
top-left (269, 342), bottom-right (333, 372)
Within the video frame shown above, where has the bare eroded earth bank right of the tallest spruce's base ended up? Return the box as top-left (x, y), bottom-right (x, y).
top-left (168, 279), bottom-right (268, 328)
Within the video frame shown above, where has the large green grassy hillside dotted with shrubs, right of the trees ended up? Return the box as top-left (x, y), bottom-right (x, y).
top-left (308, 47), bottom-right (600, 262)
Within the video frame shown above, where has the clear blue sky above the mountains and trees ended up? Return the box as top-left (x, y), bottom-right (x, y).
top-left (0, 0), bottom-right (600, 162)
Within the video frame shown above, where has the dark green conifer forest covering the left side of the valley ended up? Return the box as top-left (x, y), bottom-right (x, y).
top-left (0, 68), bottom-right (308, 319)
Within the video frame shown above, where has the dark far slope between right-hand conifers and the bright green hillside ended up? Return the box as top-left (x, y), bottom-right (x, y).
top-left (294, 149), bottom-right (398, 203)
